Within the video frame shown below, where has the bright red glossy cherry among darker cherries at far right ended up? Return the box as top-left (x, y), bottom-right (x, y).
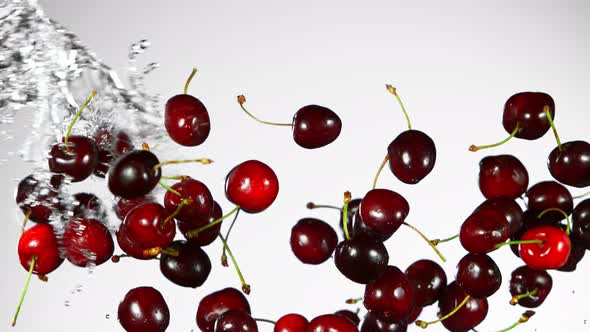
top-left (519, 226), bottom-right (571, 270)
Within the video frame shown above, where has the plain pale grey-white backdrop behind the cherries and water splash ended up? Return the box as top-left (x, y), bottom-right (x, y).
top-left (0, 0), bottom-right (590, 332)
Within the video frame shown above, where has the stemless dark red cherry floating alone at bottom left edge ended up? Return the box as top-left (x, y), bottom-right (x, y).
top-left (117, 287), bottom-right (170, 332)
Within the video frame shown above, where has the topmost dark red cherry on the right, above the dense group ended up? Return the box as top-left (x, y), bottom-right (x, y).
top-left (502, 92), bottom-right (555, 140)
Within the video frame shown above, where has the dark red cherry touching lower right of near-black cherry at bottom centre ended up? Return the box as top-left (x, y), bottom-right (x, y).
top-left (363, 266), bottom-right (415, 320)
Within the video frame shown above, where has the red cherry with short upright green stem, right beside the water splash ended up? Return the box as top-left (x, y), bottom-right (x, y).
top-left (164, 68), bottom-right (211, 146)
